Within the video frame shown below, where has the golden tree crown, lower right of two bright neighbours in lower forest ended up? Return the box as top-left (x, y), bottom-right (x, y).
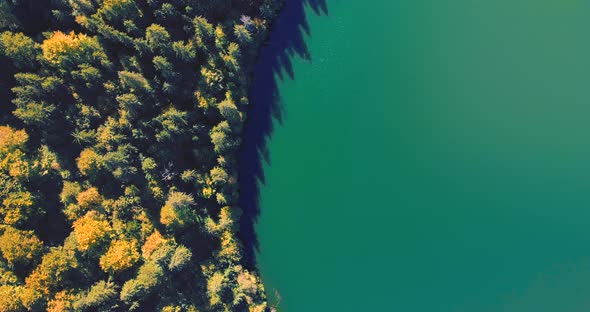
top-left (100, 240), bottom-right (139, 272)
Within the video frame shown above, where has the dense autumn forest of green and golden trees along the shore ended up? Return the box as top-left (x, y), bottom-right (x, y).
top-left (0, 0), bottom-right (279, 312)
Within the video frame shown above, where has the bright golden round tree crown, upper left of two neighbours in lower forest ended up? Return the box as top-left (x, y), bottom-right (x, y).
top-left (74, 211), bottom-right (112, 251)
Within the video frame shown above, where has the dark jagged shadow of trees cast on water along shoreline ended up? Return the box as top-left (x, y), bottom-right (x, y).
top-left (238, 0), bottom-right (328, 268)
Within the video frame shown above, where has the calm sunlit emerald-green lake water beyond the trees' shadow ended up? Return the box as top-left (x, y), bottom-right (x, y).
top-left (251, 0), bottom-right (590, 312)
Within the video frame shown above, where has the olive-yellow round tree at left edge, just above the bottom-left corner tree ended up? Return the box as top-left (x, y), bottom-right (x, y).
top-left (0, 227), bottom-right (43, 266)
